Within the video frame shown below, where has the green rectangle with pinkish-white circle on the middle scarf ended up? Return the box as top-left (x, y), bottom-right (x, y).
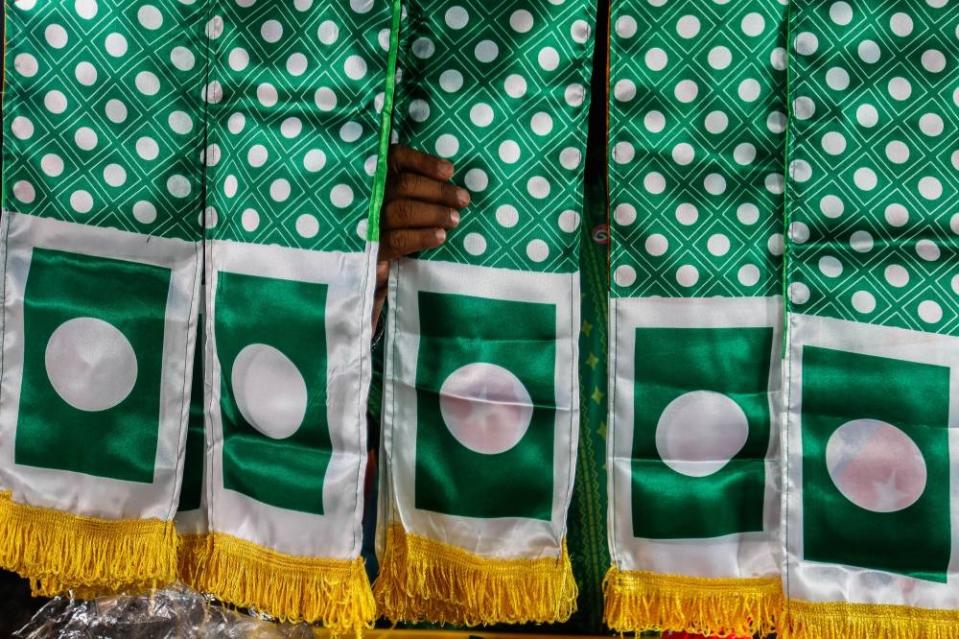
top-left (415, 291), bottom-right (556, 521)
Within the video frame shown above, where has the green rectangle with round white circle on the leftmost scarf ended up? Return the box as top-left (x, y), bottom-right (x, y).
top-left (14, 248), bottom-right (171, 483)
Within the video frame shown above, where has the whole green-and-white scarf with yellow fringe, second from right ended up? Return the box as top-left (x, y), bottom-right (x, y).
top-left (605, 0), bottom-right (786, 636)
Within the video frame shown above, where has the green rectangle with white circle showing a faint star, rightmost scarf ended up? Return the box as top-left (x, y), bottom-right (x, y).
top-left (801, 346), bottom-right (952, 583)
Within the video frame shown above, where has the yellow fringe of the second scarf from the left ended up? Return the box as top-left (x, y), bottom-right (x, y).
top-left (186, 533), bottom-right (376, 635)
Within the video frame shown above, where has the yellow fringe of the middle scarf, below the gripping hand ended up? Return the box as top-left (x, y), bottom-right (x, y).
top-left (373, 524), bottom-right (577, 626)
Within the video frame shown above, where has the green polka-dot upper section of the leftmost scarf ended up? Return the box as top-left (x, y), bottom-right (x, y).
top-left (3, 0), bottom-right (208, 240)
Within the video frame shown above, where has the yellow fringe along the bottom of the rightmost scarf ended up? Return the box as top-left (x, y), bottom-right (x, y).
top-left (780, 600), bottom-right (959, 639)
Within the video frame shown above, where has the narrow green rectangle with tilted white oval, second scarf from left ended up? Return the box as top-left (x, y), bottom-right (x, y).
top-left (214, 272), bottom-right (333, 515)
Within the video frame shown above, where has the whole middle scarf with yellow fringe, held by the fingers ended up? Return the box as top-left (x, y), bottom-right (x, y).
top-left (374, 0), bottom-right (592, 625)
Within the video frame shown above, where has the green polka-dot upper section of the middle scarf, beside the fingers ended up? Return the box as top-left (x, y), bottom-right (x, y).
top-left (395, 0), bottom-right (593, 272)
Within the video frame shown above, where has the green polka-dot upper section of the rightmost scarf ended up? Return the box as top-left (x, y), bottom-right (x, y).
top-left (787, 0), bottom-right (959, 335)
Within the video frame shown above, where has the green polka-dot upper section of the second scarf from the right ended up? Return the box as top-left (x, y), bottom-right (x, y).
top-left (609, 0), bottom-right (786, 297)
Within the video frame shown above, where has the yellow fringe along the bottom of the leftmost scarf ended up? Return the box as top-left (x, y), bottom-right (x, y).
top-left (0, 491), bottom-right (178, 596)
